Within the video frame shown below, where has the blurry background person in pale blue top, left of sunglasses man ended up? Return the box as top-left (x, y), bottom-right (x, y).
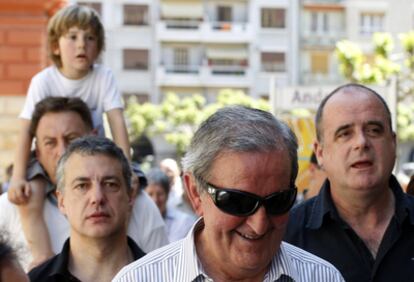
top-left (145, 168), bottom-right (196, 242)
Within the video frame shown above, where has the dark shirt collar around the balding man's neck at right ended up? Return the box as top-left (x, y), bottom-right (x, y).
top-left (306, 175), bottom-right (414, 229)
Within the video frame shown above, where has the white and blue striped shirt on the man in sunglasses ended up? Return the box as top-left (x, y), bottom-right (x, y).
top-left (112, 219), bottom-right (345, 282)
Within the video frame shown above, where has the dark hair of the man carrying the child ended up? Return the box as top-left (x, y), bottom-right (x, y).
top-left (29, 97), bottom-right (93, 138)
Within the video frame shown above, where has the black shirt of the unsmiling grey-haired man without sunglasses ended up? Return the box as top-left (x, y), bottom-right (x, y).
top-left (29, 237), bottom-right (145, 282)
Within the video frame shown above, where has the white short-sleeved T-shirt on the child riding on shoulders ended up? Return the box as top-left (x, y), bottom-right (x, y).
top-left (20, 65), bottom-right (123, 136)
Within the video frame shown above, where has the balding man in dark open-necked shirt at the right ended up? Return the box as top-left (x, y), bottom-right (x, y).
top-left (285, 84), bottom-right (414, 282)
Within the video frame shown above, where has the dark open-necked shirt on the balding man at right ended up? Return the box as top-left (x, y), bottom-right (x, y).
top-left (284, 176), bottom-right (414, 282)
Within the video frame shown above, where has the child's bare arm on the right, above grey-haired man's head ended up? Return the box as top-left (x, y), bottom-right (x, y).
top-left (106, 108), bottom-right (131, 161)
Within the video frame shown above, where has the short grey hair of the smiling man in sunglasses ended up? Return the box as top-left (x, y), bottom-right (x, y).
top-left (182, 106), bottom-right (298, 191)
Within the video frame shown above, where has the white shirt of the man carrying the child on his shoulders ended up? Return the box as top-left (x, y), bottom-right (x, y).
top-left (0, 191), bottom-right (168, 269)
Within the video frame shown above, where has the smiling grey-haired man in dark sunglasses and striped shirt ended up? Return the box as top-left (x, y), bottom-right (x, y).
top-left (114, 106), bottom-right (343, 282)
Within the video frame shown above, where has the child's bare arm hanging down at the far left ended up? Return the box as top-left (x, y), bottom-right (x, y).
top-left (8, 119), bottom-right (32, 205)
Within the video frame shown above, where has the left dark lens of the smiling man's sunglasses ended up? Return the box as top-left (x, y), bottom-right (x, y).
top-left (216, 191), bottom-right (257, 216)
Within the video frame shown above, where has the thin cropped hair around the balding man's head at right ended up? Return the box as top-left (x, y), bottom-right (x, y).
top-left (315, 83), bottom-right (392, 141)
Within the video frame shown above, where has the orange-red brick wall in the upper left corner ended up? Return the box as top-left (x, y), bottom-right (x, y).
top-left (0, 0), bottom-right (66, 96)
